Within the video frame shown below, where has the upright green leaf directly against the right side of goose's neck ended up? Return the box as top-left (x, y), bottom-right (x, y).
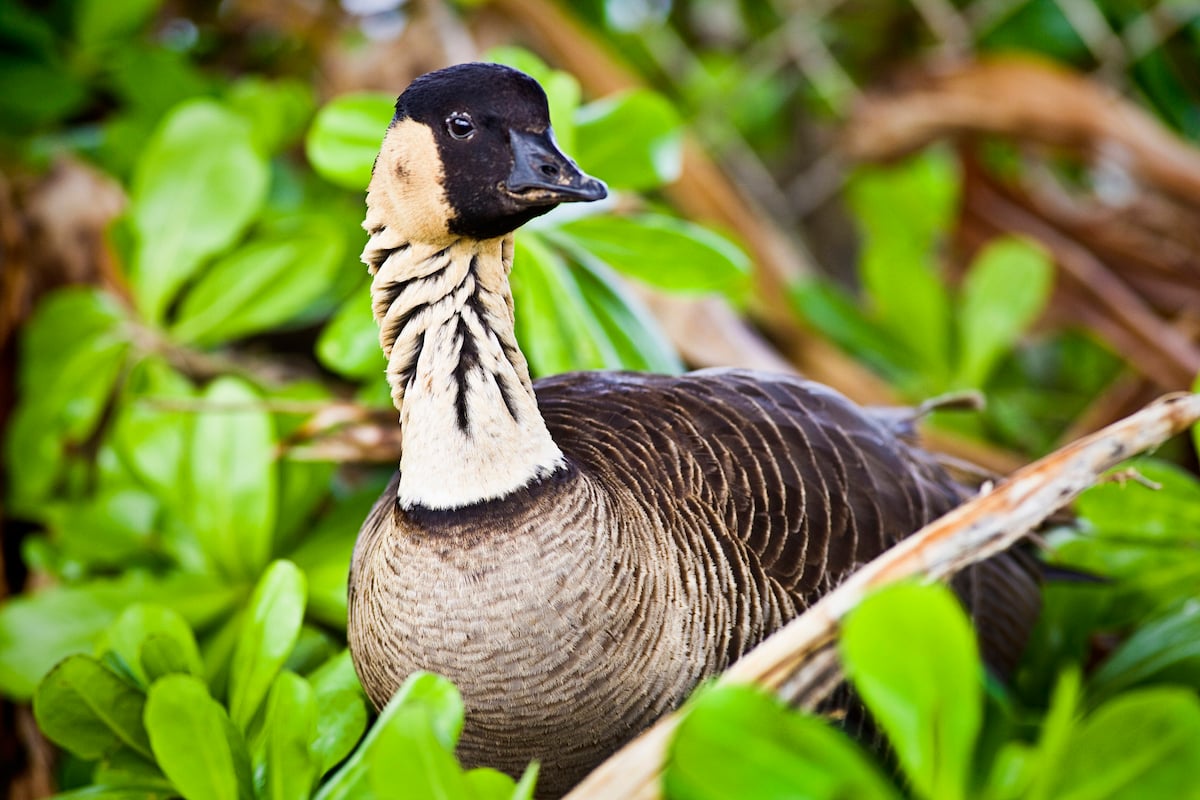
top-left (511, 233), bottom-right (619, 375)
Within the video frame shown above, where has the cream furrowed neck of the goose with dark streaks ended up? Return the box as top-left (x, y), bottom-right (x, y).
top-left (362, 229), bottom-right (564, 509)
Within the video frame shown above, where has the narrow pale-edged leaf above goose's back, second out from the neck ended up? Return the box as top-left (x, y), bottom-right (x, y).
top-left (572, 259), bottom-right (684, 374)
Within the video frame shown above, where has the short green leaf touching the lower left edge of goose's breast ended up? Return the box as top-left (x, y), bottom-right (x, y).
top-left (308, 650), bottom-right (367, 775)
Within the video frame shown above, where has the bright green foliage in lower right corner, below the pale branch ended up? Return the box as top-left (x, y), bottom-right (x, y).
top-left (665, 563), bottom-right (1200, 800)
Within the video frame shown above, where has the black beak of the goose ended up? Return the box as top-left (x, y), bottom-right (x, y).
top-left (506, 128), bottom-right (608, 205)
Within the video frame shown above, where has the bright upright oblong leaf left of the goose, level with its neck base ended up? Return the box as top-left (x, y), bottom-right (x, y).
top-left (186, 377), bottom-right (277, 578)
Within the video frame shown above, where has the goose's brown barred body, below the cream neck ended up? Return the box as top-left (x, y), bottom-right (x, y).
top-left (349, 369), bottom-right (1037, 795)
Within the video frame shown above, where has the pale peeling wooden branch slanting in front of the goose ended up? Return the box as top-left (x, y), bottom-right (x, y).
top-left (566, 393), bottom-right (1200, 800)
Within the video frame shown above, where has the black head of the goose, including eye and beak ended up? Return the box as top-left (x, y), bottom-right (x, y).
top-left (386, 64), bottom-right (607, 239)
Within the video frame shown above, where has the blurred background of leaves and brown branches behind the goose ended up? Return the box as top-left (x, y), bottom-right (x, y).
top-left (0, 0), bottom-right (1200, 798)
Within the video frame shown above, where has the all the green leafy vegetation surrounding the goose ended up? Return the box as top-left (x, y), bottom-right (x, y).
top-left (0, 0), bottom-right (1200, 800)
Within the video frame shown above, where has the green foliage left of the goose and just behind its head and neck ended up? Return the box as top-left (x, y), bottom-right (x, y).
top-left (0, 0), bottom-right (749, 798)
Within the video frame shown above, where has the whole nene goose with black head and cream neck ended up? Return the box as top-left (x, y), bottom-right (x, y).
top-left (349, 64), bottom-right (1037, 794)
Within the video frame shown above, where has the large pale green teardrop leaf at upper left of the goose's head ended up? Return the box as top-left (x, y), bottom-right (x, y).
top-left (130, 100), bottom-right (268, 323)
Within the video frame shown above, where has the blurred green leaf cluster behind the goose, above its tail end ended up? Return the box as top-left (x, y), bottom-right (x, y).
top-left (792, 149), bottom-right (1118, 453)
